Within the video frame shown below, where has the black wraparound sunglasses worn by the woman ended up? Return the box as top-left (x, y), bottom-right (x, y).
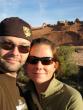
top-left (26, 56), bottom-right (54, 65)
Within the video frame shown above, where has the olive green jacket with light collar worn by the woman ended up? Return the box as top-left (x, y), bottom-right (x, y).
top-left (27, 78), bottom-right (83, 110)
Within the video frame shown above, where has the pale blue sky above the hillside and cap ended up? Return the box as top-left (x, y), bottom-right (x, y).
top-left (0, 0), bottom-right (83, 27)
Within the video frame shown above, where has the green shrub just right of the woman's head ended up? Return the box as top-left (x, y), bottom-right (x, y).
top-left (58, 46), bottom-right (79, 76)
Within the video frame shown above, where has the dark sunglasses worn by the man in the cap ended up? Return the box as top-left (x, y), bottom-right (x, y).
top-left (0, 41), bottom-right (30, 53)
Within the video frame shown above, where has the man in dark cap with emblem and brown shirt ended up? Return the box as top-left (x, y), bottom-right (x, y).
top-left (0, 17), bottom-right (31, 110)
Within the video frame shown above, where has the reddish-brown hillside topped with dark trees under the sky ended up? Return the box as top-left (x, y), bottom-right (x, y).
top-left (32, 19), bottom-right (83, 45)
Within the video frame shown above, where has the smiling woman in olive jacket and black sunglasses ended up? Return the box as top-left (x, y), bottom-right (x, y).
top-left (25, 38), bottom-right (83, 110)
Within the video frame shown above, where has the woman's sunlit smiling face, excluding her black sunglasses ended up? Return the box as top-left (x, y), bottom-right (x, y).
top-left (26, 44), bottom-right (57, 84)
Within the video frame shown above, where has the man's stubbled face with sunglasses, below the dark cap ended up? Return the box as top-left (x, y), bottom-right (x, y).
top-left (0, 36), bottom-right (30, 72)
